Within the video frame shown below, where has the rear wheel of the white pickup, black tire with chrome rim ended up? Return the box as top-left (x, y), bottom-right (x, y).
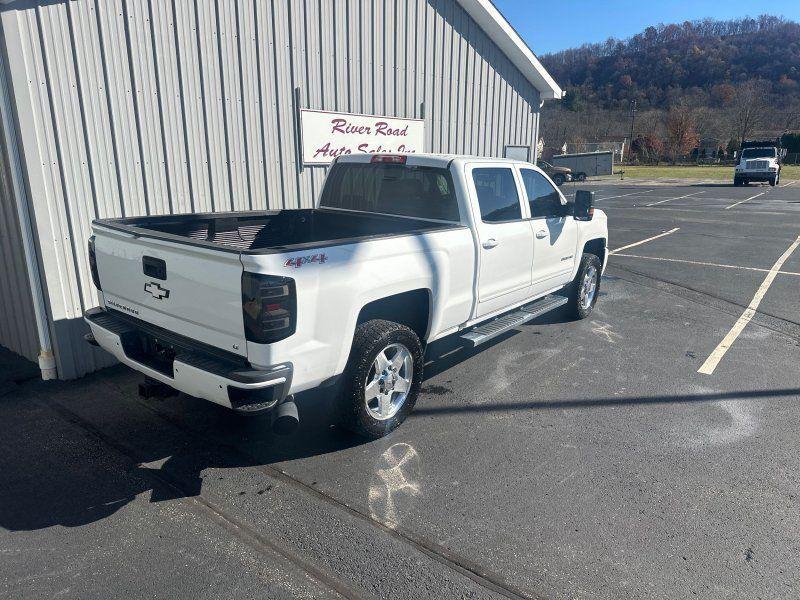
top-left (340, 319), bottom-right (423, 440)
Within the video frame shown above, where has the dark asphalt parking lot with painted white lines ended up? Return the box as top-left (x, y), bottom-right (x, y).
top-left (0, 176), bottom-right (800, 599)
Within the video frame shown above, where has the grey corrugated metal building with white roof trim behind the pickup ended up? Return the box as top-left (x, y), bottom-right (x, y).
top-left (0, 0), bottom-right (561, 378)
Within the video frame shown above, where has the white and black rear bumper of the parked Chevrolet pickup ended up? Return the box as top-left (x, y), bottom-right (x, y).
top-left (84, 308), bottom-right (293, 414)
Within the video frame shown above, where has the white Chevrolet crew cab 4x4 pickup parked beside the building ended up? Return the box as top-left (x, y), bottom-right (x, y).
top-left (85, 154), bottom-right (608, 438)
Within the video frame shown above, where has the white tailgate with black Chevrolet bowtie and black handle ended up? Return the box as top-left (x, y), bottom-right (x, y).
top-left (95, 227), bottom-right (247, 356)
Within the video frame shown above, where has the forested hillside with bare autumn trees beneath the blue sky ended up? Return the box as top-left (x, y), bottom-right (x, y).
top-left (542, 15), bottom-right (800, 158)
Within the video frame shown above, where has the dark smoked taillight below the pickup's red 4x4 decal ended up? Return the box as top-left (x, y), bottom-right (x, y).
top-left (242, 272), bottom-right (297, 344)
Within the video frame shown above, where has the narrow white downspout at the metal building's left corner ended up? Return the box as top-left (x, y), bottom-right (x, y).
top-left (0, 43), bottom-right (58, 380)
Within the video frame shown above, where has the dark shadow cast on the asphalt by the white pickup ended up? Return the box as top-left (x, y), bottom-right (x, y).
top-left (0, 311), bottom-right (576, 531)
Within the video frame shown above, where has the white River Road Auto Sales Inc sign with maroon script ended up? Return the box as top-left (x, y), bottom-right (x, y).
top-left (300, 109), bottom-right (425, 165)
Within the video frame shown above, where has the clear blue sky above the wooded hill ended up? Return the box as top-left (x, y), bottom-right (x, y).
top-left (493, 0), bottom-right (800, 54)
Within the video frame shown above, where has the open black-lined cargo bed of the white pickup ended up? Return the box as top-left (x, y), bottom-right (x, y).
top-left (95, 208), bottom-right (462, 254)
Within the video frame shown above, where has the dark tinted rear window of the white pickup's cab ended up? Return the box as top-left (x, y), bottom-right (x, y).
top-left (320, 163), bottom-right (460, 221)
